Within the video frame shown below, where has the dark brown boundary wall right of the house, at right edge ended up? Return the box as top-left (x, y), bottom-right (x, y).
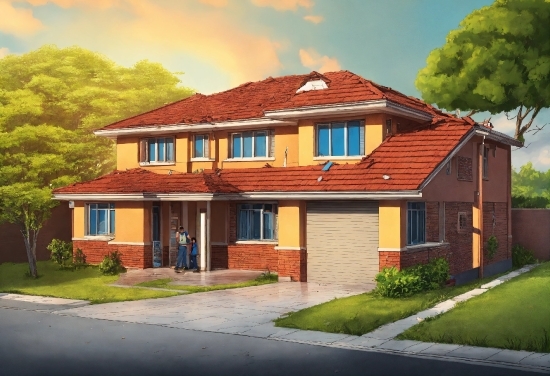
top-left (509, 209), bottom-right (550, 260)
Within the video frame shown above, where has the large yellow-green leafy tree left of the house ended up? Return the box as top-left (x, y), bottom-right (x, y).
top-left (0, 45), bottom-right (192, 277)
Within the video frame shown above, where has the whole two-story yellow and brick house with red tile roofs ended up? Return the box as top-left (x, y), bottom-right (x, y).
top-left (54, 71), bottom-right (521, 283)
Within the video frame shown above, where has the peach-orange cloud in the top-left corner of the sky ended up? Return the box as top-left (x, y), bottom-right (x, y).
top-left (0, 0), bottom-right (44, 36)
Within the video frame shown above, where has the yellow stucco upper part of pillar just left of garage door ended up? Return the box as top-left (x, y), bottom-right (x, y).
top-left (278, 201), bottom-right (305, 247)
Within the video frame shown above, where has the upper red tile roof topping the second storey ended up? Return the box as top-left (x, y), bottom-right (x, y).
top-left (102, 71), bottom-right (441, 130)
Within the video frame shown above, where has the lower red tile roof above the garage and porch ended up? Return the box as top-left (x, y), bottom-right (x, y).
top-left (54, 116), bottom-right (473, 194)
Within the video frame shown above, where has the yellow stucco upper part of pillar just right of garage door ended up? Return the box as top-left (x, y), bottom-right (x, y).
top-left (378, 201), bottom-right (405, 248)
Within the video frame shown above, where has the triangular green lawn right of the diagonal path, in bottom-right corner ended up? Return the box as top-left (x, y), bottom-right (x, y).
top-left (398, 262), bottom-right (550, 352)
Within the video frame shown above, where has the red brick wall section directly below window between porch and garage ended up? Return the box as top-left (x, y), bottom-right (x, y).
top-left (227, 244), bottom-right (279, 272)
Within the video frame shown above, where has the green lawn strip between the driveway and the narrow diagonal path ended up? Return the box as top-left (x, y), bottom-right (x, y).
top-left (275, 276), bottom-right (512, 335)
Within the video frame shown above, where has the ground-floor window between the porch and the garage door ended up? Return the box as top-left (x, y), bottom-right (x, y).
top-left (237, 204), bottom-right (277, 240)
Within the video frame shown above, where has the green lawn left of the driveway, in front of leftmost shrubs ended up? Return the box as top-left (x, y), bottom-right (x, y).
top-left (0, 261), bottom-right (179, 304)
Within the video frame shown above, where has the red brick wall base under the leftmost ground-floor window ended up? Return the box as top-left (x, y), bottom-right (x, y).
top-left (73, 240), bottom-right (153, 269)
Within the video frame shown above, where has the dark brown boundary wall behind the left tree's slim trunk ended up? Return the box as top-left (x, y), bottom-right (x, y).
top-left (0, 202), bottom-right (72, 264)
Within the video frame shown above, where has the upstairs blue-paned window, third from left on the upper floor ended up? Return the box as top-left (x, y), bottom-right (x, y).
top-left (231, 130), bottom-right (275, 158)
